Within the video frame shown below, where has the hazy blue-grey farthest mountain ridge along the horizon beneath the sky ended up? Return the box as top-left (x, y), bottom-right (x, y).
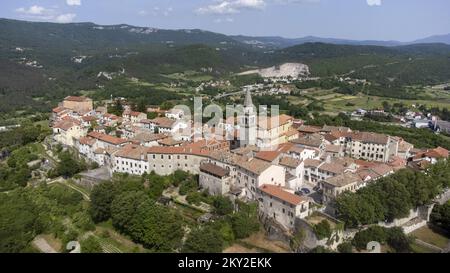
top-left (0, 18), bottom-right (450, 49)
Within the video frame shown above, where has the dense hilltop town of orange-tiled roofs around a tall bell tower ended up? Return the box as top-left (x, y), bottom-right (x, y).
top-left (52, 90), bottom-right (449, 250)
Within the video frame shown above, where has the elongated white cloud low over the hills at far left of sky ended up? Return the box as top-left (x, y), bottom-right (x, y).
top-left (15, 5), bottom-right (76, 23)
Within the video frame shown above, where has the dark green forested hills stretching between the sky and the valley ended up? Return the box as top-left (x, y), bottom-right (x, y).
top-left (0, 19), bottom-right (450, 113)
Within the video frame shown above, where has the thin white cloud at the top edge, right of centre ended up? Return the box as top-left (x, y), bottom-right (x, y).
top-left (196, 0), bottom-right (266, 14)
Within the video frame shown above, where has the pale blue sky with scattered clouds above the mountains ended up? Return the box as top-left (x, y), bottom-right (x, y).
top-left (0, 0), bottom-right (450, 41)
